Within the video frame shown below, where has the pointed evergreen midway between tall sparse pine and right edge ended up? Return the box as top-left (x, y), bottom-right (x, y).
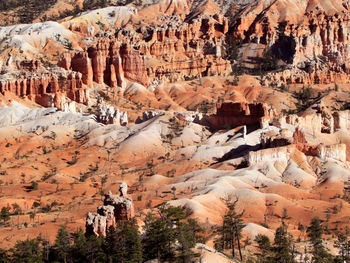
top-left (273, 224), bottom-right (295, 263)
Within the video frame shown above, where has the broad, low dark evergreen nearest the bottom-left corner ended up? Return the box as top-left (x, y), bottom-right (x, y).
top-left (11, 238), bottom-right (44, 263)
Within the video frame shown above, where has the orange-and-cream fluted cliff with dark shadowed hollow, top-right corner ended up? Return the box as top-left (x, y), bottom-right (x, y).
top-left (232, 0), bottom-right (350, 84)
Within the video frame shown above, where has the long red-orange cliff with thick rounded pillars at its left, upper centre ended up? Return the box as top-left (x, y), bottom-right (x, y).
top-left (59, 15), bottom-right (231, 88)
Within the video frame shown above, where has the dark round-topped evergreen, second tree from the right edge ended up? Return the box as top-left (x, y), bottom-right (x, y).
top-left (307, 217), bottom-right (331, 263)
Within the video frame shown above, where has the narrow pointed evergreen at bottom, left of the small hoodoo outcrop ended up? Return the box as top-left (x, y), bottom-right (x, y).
top-left (53, 226), bottom-right (71, 263)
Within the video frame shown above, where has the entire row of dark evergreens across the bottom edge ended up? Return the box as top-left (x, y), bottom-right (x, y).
top-left (0, 205), bottom-right (350, 263)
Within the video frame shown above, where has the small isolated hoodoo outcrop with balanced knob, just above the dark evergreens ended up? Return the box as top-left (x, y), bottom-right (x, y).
top-left (86, 182), bottom-right (135, 236)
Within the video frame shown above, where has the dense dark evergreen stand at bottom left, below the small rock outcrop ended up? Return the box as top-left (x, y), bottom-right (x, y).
top-left (0, 205), bottom-right (203, 263)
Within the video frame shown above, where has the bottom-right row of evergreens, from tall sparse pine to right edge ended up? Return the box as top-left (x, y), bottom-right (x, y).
top-left (214, 204), bottom-right (350, 263)
